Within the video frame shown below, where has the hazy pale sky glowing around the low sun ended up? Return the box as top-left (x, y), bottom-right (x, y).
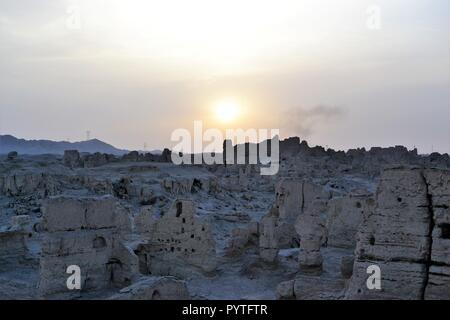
top-left (0, 0), bottom-right (450, 153)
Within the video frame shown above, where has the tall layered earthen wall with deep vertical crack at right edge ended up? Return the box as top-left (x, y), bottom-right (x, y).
top-left (346, 168), bottom-right (450, 299)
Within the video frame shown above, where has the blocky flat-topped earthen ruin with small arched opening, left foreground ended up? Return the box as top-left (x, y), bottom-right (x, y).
top-left (39, 196), bottom-right (138, 296)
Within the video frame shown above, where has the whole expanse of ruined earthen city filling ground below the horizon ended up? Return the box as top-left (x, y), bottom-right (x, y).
top-left (0, 138), bottom-right (450, 300)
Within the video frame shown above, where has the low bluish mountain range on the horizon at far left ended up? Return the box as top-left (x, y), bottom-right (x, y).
top-left (0, 135), bottom-right (129, 155)
